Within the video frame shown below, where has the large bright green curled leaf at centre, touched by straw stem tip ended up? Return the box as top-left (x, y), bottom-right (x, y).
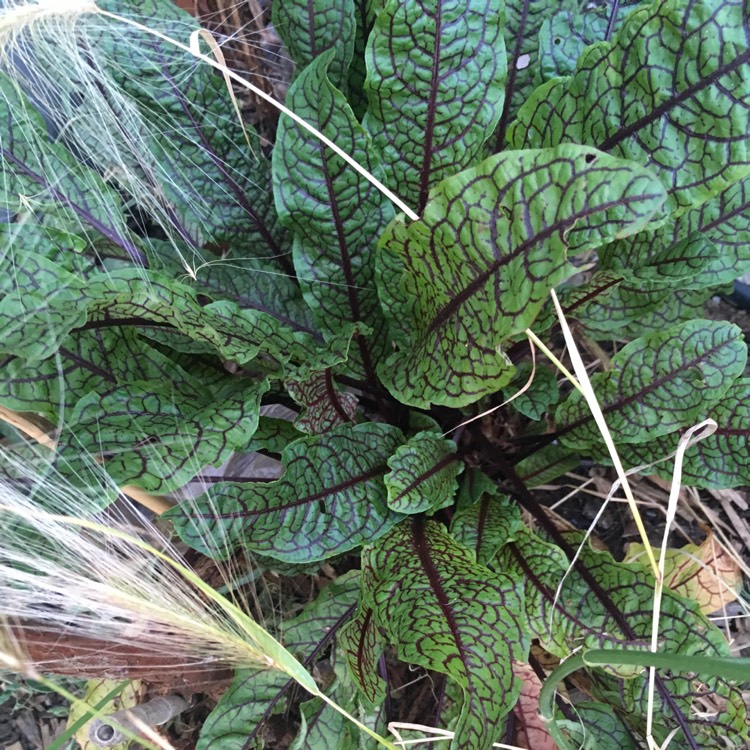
top-left (379, 146), bottom-right (664, 407)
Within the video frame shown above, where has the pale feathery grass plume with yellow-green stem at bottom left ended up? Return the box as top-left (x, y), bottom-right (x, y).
top-left (0, 446), bottom-right (400, 748)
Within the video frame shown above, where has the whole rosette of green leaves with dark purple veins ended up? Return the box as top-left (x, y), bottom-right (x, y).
top-left (0, 0), bottom-right (750, 750)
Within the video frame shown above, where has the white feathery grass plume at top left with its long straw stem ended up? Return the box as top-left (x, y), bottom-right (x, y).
top-left (0, 0), bottom-right (416, 276)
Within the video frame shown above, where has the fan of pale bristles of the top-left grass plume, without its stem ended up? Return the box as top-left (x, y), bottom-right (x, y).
top-left (0, 0), bottom-right (274, 272)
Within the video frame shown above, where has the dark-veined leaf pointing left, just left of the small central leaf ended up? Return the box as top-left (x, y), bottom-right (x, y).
top-left (166, 422), bottom-right (403, 563)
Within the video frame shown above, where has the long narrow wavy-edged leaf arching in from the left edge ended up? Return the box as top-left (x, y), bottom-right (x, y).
top-left (0, 248), bottom-right (334, 374)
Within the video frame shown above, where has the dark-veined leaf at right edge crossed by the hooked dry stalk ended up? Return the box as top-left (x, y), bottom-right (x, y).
top-left (618, 378), bottom-right (750, 488)
